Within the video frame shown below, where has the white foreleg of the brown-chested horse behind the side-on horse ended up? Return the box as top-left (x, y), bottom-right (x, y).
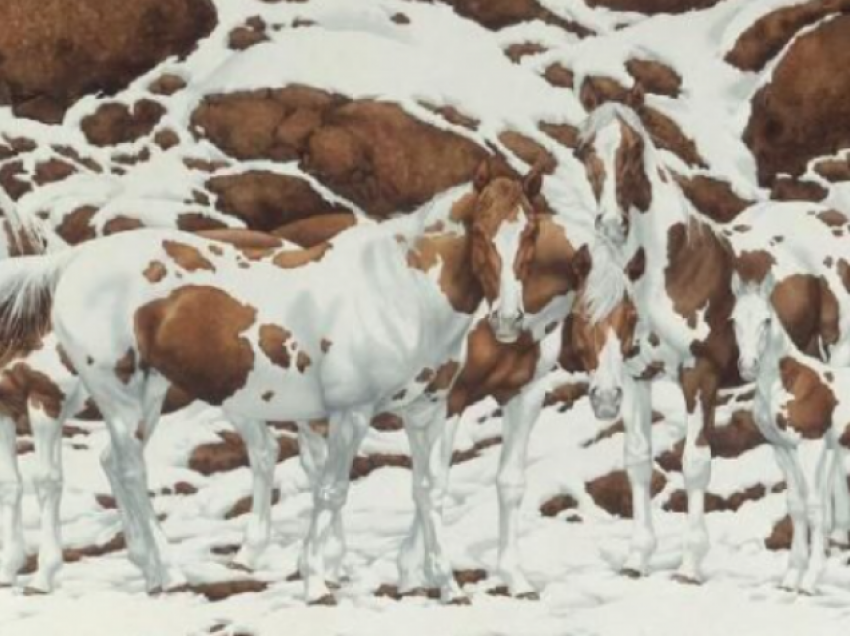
top-left (496, 382), bottom-right (546, 600)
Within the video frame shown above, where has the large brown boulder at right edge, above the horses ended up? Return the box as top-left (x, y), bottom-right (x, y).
top-left (744, 15), bottom-right (850, 186)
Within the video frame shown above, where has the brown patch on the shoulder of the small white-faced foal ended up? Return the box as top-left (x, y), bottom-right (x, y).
top-left (779, 357), bottom-right (838, 439)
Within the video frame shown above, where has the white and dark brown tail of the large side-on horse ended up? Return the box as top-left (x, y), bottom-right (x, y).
top-left (0, 249), bottom-right (77, 351)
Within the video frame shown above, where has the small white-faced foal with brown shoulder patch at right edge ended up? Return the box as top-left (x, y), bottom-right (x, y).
top-left (732, 275), bottom-right (850, 594)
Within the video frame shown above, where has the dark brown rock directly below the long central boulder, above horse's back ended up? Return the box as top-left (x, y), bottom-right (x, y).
top-left (206, 170), bottom-right (347, 232)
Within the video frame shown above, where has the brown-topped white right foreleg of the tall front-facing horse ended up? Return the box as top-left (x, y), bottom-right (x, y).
top-left (675, 359), bottom-right (717, 583)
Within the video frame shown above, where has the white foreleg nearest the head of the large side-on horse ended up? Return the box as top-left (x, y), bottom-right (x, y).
top-left (404, 400), bottom-right (460, 603)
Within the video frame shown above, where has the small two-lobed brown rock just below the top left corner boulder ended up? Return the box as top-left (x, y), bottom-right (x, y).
top-left (81, 99), bottom-right (165, 146)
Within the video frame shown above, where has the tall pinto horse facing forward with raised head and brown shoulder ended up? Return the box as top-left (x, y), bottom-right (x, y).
top-left (576, 98), bottom-right (848, 582)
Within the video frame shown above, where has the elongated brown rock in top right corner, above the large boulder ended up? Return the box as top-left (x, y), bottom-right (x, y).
top-left (725, 0), bottom-right (850, 71)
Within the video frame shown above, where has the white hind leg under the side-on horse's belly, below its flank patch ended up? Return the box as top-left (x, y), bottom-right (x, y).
top-left (230, 416), bottom-right (277, 571)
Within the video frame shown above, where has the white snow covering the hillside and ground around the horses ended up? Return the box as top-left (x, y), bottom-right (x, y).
top-left (0, 0), bottom-right (850, 636)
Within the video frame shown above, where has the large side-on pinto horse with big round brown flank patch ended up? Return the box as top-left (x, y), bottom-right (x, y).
top-left (0, 161), bottom-right (540, 602)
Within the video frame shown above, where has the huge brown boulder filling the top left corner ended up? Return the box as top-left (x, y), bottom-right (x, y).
top-left (0, 0), bottom-right (217, 123)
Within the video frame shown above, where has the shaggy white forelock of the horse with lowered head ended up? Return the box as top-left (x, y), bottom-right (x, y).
top-left (580, 236), bottom-right (629, 324)
